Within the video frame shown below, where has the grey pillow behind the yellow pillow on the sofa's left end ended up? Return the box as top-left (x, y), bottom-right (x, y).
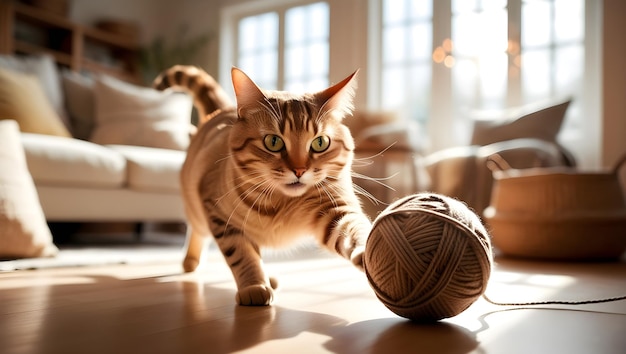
top-left (0, 55), bottom-right (70, 129)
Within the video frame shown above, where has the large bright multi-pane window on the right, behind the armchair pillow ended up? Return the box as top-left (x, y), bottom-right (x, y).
top-left (374, 0), bottom-right (585, 162)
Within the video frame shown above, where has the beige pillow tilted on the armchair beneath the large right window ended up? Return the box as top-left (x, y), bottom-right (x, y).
top-left (471, 99), bottom-right (571, 146)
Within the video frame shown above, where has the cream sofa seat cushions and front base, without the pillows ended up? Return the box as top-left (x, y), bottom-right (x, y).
top-left (21, 133), bottom-right (185, 222)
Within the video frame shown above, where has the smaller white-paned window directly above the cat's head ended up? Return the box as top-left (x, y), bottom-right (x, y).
top-left (230, 2), bottom-right (329, 92)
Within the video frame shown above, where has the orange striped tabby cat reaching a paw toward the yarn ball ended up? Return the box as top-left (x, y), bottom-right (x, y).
top-left (154, 66), bottom-right (372, 305)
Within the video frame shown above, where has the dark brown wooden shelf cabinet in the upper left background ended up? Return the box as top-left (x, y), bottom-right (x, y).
top-left (0, 0), bottom-right (141, 83)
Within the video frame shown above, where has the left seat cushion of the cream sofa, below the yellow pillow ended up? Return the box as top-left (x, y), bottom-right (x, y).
top-left (22, 133), bottom-right (126, 188)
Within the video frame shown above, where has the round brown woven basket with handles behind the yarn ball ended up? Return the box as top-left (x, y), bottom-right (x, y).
top-left (484, 156), bottom-right (626, 260)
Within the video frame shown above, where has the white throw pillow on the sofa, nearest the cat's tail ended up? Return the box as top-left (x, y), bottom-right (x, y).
top-left (90, 76), bottom-right (192, 150)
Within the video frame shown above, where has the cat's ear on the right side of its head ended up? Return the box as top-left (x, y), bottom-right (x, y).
top-left (315, 70), bottom-right (359, 119)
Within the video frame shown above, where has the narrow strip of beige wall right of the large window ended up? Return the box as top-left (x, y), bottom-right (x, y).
top-left (602, 0), bottom-right (626, 194)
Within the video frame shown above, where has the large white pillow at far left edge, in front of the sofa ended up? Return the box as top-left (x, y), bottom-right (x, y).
top-left (0, 120), bottom-right (58, 259)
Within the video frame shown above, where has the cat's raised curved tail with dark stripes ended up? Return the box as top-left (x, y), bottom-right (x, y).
top-left (152, 65), bottom-right (235, 124)
